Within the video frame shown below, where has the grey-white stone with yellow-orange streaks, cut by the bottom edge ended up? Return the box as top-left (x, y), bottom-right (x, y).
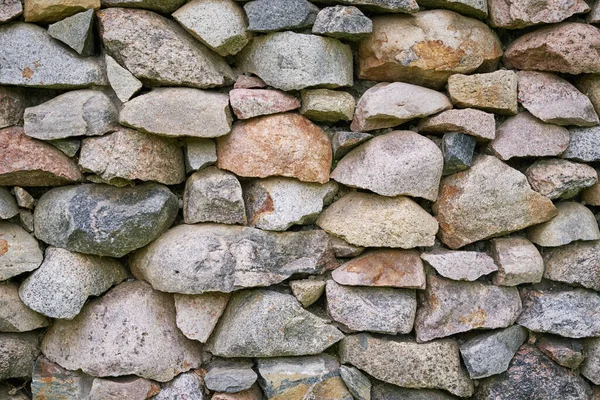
top-left (256, 354), bottom-right (352, 400)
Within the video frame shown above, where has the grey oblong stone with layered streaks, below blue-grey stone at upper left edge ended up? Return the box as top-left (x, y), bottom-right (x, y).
top-left (23, 90), bottom-right (118, 140)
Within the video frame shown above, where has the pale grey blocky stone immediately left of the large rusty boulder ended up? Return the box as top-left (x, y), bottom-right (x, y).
top-left (237, 31), bottom-right (353, 90)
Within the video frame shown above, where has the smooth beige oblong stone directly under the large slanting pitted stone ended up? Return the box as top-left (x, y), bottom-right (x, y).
top-left (119, 88), bottom-right (232, 138)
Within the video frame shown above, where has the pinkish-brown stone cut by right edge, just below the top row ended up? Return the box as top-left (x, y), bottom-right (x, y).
top-left (503, 22), bottom-right (600, 75)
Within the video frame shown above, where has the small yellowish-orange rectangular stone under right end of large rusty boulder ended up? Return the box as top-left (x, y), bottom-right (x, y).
top-left (448, 70), bottom-right (517, 115)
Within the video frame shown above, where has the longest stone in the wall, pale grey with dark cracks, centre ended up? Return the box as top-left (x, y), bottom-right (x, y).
top-left (130, 224), bottom-right (334, 294)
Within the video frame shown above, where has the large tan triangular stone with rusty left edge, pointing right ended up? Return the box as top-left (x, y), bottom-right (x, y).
top-left (433, 155), bottom-right (557, 249)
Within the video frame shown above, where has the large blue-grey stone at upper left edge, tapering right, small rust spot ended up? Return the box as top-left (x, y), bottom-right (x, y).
top-left (0, 22), bottom-right (107, 89)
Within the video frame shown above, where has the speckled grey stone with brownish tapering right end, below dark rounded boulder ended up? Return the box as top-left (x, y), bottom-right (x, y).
top-left (19, 247), bottom-right (127, 319)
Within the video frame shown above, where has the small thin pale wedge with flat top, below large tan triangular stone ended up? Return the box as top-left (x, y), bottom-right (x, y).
top-left (421, 250), bottom-right (498, 281)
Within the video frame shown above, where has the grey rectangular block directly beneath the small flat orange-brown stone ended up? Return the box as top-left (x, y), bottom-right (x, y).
top-left (325, 280), bottom-right (417, 335)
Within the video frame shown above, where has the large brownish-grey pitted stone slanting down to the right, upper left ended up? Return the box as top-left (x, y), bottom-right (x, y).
top-left (96, 8), bottom-right (233, 89)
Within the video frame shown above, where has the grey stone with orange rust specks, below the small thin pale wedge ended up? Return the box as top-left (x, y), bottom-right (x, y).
top-left (415, 275), bottom-right (521, 342)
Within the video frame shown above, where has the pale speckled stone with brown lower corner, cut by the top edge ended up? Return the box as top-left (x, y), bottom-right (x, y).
top-left (173, 0), bottom-right (252, 56)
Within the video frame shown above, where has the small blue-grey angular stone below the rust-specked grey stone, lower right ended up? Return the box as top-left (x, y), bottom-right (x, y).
top-left (460, 325), bottom-right (527, 379)
